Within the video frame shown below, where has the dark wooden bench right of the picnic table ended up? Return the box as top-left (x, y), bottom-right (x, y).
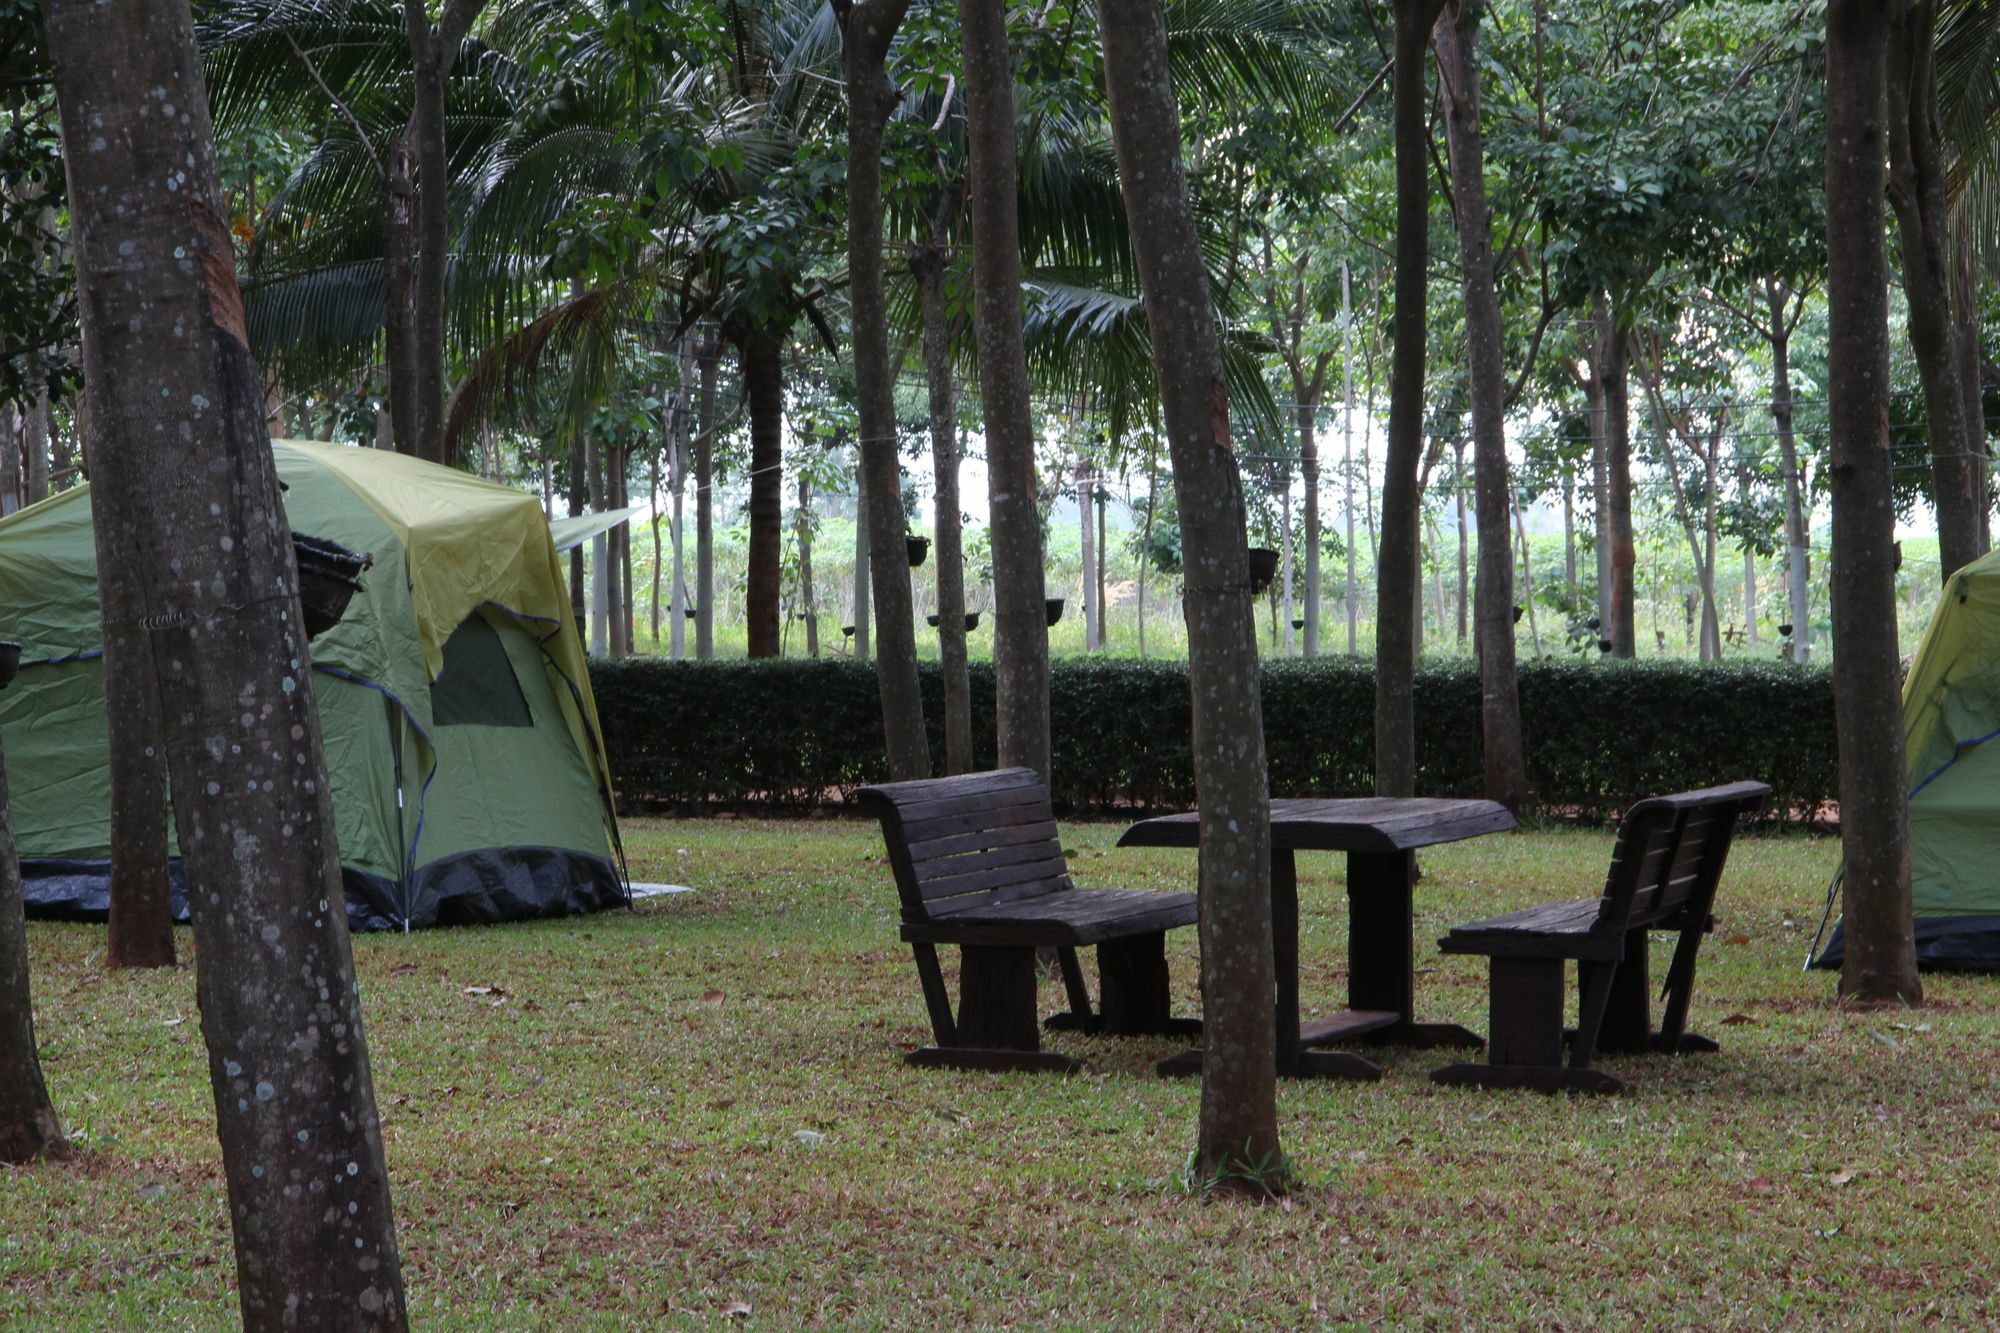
top-left (1430, 783), bottom-right (1770, 1093)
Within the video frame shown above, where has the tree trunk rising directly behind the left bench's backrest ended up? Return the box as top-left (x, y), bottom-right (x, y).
top-left (836, 0), bottom-right (936, 781)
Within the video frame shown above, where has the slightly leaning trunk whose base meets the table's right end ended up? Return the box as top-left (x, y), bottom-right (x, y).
top-left (1436, 0), bottom-right (1528, 815)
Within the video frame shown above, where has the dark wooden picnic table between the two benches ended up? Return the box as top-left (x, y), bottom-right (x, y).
top-left (1118, 797), bottom-right (1514, 1079)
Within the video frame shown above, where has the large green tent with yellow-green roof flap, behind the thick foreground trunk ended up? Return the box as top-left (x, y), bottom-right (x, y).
top-left (0, 440), bottom-right (628, 929)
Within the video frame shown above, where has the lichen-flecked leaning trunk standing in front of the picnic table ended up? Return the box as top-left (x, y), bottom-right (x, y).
top-left (1098, 0), bottom-right (1290, 1193)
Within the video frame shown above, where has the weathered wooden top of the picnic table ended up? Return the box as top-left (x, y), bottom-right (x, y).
top-left (1118, 797), bottom-right (1516, 853)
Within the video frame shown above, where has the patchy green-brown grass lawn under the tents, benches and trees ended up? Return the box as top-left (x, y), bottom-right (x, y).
top-left (0, 821), bottom-right (2000, 1329)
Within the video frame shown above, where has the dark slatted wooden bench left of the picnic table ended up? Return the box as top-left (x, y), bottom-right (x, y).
top-left (854, 769), bottom-right (1200, 1071)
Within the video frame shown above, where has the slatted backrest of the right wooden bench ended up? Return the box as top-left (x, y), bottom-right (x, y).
top-left (1594, 783), bottom-right (1770, 935)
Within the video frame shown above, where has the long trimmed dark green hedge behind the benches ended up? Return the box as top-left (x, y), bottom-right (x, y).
top-left (590, 658), bottom-right (1838, 817)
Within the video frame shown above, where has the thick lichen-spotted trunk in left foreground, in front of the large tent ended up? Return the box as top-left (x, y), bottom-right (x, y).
top-left (44, 0), bottom-right (406, 1304)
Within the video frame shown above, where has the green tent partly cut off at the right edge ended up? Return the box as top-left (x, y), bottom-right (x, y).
top-left (1814, 550), bottom-right (2000, 971)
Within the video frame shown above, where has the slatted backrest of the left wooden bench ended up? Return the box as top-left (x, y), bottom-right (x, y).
top-left (854, 769), bottom-right (1070, 921)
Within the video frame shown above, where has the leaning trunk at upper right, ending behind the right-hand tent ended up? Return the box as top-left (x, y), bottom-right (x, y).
top-left (1888, 0), bottom-right (1986, 578)
